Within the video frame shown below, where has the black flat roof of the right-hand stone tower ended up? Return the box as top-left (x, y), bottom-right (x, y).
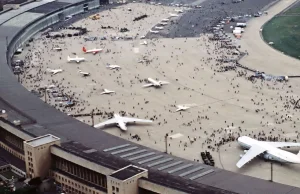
top-left (110, 165), bottom-right (146, 181)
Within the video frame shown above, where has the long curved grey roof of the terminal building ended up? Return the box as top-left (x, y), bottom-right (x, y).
top-left (0, 0), bottom-right (300, 194)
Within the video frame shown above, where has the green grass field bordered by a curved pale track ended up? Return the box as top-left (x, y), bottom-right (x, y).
top-left (262, 5), bottom-right (300, 59)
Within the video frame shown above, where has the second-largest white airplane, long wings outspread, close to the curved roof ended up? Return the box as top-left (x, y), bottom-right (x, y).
top-left (94, 114), bottom-right (153, 131)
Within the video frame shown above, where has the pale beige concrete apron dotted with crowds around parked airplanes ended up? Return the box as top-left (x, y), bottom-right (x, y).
top-left (14, 0), bottom-right (299, 186)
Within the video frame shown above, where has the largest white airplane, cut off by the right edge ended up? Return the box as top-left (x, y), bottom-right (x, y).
top-left (236, 136), bottom-right (300, 168)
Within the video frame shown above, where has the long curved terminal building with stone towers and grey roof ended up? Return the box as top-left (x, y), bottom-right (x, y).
top-left (0, 0), bottom-right (300, 194)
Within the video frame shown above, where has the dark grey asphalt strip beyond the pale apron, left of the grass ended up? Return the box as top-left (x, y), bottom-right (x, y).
top-left (163, 0), bottom-right (275, 38)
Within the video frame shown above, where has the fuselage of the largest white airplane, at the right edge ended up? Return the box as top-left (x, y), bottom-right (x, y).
top-left (238, 136), bottom-right (300, 163)
